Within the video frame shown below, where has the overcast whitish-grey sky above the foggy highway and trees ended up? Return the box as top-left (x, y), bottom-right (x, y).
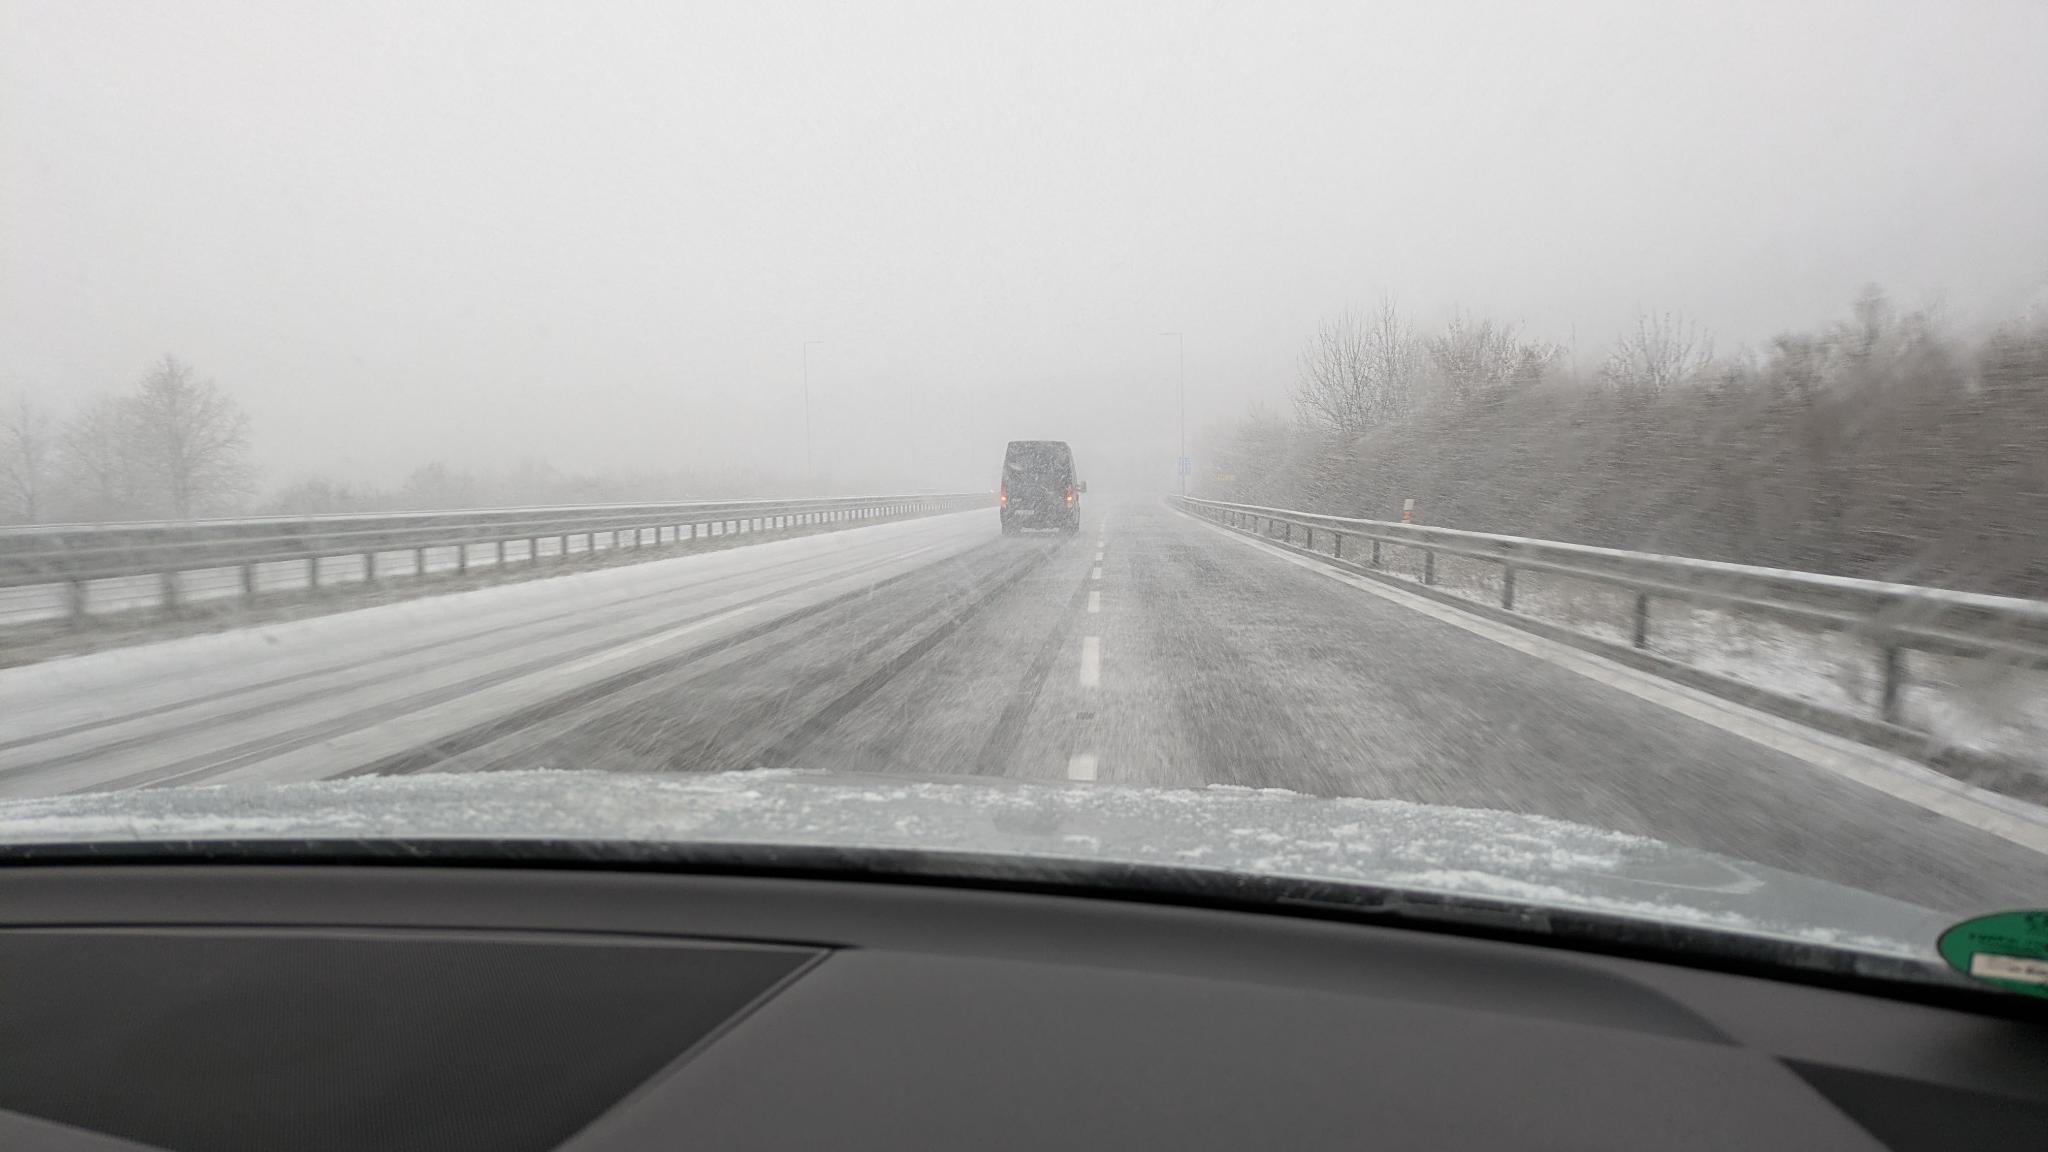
top-left (0, 0), bottom-right (2048, 488)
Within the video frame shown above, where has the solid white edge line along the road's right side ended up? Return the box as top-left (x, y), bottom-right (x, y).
top-left (1180, 512), bottom-right (2048, 853)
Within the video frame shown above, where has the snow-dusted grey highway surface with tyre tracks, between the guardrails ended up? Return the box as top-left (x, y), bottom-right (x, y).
top-left (0, 502), bottom-right (2048, 908)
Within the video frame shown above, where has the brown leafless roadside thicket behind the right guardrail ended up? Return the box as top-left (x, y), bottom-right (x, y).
top-left (1194, 289), bottom-right (2048, 596)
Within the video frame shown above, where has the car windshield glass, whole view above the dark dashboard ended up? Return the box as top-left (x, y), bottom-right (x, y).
top-left (0, 0), bottom-right (2048, 963)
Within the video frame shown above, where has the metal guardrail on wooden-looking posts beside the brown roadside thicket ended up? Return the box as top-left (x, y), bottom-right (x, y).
top-left (1171, 496), bottom-right (2048, 728)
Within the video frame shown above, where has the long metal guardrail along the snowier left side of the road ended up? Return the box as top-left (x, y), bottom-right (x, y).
top-left (0, 492), bottom-right (995, 619)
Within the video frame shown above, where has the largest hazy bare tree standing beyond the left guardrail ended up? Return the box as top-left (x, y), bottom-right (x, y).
top-left (133, 357), bottom-right (250, 519)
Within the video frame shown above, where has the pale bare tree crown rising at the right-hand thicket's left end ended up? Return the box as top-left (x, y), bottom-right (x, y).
top-left (1294, 297), bottom-right (1421, 439)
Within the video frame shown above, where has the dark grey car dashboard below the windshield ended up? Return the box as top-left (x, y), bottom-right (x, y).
top-left (0, 859), bottom-right (2048, 1152)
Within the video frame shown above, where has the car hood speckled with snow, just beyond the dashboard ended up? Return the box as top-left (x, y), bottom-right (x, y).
top-left (0, 771), bottom-right (1948, 959)
